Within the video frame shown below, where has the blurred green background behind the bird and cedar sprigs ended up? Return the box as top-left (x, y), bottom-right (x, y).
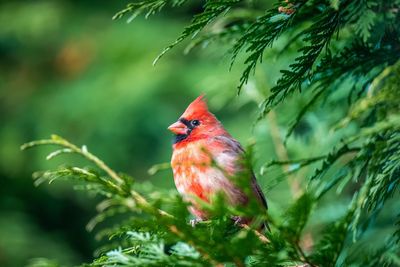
top-left (0, 0), bottom-right (396, 266)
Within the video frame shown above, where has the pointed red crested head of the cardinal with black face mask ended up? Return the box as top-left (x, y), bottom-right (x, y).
top-left (168, 95), bottom-right (227, 144)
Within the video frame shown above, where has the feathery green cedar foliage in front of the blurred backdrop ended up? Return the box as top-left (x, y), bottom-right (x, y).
top-left (22, 0), bottom-right (400, 266)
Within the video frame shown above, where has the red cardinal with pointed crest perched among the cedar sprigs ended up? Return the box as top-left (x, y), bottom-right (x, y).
top-left (168, 96), bottom-right (267, 227)
